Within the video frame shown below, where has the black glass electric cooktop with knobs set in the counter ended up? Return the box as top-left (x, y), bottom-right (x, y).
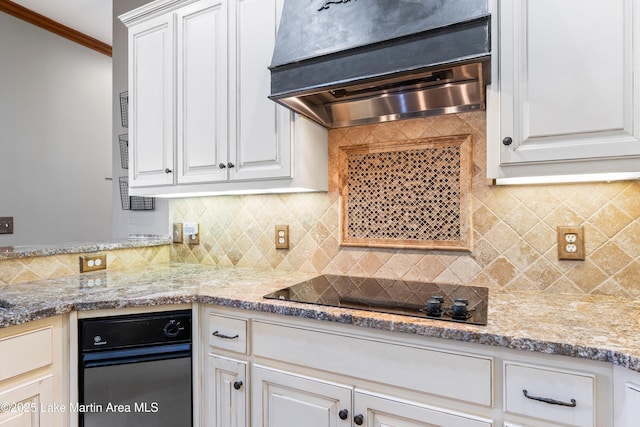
top-left (264, 275), bottom-right (489, 325)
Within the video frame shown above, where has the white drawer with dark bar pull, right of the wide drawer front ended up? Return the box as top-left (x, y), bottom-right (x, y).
top-left (505, 363), bottom-right (595, 427)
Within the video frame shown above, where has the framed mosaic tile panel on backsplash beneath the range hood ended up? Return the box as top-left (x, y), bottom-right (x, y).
top-left (340, 135), bottom-right (473, 251)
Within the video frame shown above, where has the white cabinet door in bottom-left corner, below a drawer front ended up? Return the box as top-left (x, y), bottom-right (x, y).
top-left (0, 376), bottom-right (53, 427)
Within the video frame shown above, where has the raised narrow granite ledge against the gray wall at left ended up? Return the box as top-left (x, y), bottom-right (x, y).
top-left (0, 235), bottom-right (171, 261)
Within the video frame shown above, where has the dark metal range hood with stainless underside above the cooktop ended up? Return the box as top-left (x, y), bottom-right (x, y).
top-left (269, 0), bottom-right (491, 128)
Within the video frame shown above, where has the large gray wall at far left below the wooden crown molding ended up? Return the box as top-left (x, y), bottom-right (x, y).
top-left (0, 12), bottom-right (112, 247)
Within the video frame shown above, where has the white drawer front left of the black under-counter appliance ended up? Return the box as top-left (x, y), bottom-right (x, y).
top-left (0, 328), bottom-right (53, 381)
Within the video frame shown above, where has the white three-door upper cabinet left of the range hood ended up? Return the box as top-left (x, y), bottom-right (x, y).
top-left (120, 0), bottom-right (328, 196)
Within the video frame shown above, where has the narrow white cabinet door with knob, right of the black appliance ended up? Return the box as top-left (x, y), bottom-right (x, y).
top-left (204, 355), bottom-right (248, 427)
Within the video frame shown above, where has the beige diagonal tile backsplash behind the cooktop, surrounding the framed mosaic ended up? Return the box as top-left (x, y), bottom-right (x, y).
top-left (169, 112), bottom-right (640, 298)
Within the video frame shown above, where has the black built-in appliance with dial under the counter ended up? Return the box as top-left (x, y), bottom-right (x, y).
top-left (77, 310), bottom-right (193, 427)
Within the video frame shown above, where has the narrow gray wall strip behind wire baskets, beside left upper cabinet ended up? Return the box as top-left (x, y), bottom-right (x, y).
top-left (112, 0), bottom-right (171, 239)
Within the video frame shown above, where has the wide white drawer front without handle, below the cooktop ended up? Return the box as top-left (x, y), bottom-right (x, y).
top-left (253, 321), bottom-right (493, 406)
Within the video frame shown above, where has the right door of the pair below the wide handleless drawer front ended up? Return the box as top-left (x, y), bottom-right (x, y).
top-left (354, 390), bottom-right (493, 427)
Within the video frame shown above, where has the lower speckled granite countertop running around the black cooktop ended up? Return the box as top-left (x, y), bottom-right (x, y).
top-left (0, 264), bottom-right (640, 372)
